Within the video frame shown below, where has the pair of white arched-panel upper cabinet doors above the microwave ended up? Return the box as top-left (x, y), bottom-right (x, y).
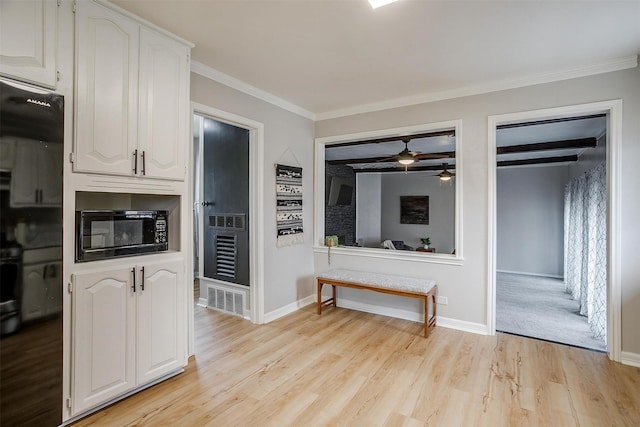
top-left (74, 1), bottom-right (190, 180)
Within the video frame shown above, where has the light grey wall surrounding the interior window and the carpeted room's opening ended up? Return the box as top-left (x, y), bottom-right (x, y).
top-left (315, 67), bottom-right (640, 354)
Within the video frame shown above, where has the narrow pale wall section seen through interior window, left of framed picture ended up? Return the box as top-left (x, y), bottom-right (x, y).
top-left (356, 173), bottom-right (382, 248)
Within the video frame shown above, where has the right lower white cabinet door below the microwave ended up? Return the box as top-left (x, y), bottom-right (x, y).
top-left (138, 260), bottom-right (184, 384)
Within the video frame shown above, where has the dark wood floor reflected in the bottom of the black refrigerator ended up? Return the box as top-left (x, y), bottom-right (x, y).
top-left (0, 316), bottom-right (62, 427)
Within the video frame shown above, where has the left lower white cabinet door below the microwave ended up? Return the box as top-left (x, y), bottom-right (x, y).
top-left (71, 269), bottom-right (136, 414)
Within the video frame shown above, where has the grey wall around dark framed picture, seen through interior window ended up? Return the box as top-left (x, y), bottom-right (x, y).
top-left (382, 171), bottom-right (455, 254)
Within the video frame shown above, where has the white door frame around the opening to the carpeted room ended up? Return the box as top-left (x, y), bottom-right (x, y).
top-left (487, 99), bottom-right (622, 362)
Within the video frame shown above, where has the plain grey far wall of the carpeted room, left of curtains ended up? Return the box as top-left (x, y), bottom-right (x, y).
top-left (496, 165), bottom-right (569, 277)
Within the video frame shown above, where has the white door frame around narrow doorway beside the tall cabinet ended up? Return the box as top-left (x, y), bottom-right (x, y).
top-left (185, 102), bottom-right (264, 354)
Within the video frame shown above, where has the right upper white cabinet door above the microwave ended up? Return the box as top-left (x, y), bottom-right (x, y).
top-left (138, 27), bottom-right (189, 180)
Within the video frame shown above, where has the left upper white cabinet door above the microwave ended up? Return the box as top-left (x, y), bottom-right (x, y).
top-left (74, 1), bottom-right (139, 175)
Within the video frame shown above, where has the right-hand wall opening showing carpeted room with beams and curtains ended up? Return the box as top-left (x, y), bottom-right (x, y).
top-left (495, 113), bottom-right (610, 351)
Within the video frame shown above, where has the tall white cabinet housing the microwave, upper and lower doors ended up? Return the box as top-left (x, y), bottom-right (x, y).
top-left (65, 0), bottom-right (192, 417)
